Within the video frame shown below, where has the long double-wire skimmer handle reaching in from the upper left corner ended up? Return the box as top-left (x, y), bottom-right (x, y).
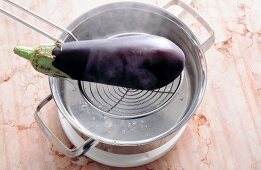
top-left (0, 0), bottom-right (77, 42)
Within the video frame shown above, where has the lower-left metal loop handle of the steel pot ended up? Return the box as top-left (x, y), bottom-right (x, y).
top-left (34, 94), bottom-right (98, 158)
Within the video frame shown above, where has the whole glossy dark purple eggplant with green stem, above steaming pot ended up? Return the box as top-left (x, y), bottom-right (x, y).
top-left (14, 35), bottom-right (185, 90)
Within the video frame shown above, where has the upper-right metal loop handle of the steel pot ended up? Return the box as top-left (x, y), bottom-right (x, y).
top-left (163, 0), bottom-right (215, 52)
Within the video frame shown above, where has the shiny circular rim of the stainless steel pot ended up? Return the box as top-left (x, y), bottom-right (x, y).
top-left (49, 2), bottom-right (207, 146)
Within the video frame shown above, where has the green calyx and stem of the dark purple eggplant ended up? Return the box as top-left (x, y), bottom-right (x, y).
top-left (14, 45), bottom-right (70, 78)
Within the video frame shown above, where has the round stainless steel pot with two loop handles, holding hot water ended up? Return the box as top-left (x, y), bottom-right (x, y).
top-left (35, 0), bottom-right (214, 157)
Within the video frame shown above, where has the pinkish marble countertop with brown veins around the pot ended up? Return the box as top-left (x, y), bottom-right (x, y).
top-left (0, 0), bottom-right (261, 170)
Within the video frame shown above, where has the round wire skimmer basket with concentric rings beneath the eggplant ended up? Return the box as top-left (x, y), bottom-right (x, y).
top-left (79, 71), bottom-right (182, 119)
